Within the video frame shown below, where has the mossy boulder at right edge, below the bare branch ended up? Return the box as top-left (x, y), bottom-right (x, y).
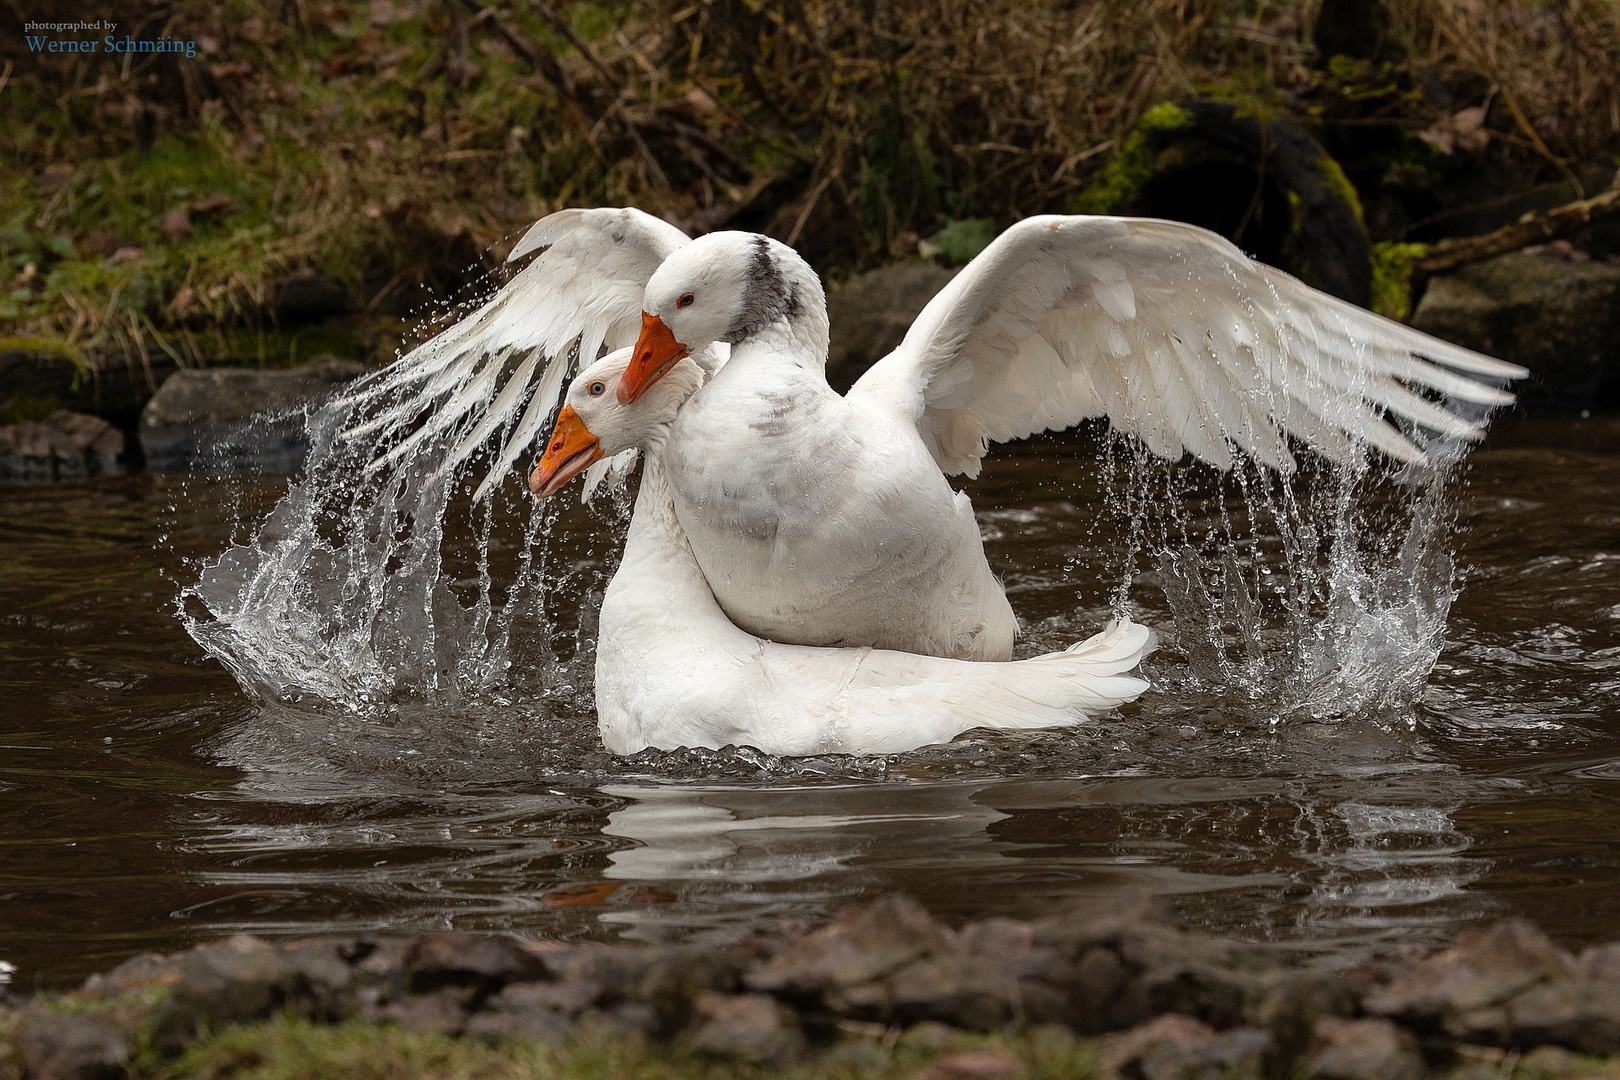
top-left (1411, 253), bottom-right (1620, 410)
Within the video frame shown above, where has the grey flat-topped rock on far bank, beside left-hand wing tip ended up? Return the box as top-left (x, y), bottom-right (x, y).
top-left (141, 356), bottom-right (365, 473)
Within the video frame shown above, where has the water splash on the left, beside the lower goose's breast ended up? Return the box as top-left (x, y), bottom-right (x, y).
top-left (180, 365), bottom-right (609, 716)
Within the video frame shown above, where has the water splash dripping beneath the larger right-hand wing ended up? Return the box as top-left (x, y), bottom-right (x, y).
top-left (1105, 424), bottom-right (1461, 724)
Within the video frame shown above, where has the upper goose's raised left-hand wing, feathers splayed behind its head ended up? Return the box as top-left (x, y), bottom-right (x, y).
top-left (343, 207), bottom-right (687, 499)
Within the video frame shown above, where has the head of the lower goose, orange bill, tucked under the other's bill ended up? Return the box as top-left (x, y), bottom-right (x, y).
top-left (528, 348), bottom-right (703, 499)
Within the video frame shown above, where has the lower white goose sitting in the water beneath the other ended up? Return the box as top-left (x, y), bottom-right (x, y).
top-left (530, 350), bottom-right (1150, 756)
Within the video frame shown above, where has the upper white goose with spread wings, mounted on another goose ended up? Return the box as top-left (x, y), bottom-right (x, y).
top-left (338, 209), bottom-right (1526, 661)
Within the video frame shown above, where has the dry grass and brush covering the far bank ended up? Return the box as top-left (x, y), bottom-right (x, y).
top-left (0, 0), bottom-right (1620, 378)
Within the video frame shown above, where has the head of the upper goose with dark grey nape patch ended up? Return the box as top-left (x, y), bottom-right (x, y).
top-left (619, 233), bottom-right (826, 402)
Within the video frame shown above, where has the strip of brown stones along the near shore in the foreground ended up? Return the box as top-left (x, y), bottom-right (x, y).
top-left (9, 897), bottom-right (1620, 1080)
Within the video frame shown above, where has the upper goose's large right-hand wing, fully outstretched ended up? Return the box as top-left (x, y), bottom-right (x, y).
top-left (851, 217), bottom-right (1526, 476)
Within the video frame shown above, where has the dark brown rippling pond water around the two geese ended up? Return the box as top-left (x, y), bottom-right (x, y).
top-left (0, 427), bottom-right (1620, 988)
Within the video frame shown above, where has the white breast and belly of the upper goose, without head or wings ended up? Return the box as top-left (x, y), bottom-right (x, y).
top-left (664, 323), bottom-right (1017, 661)
